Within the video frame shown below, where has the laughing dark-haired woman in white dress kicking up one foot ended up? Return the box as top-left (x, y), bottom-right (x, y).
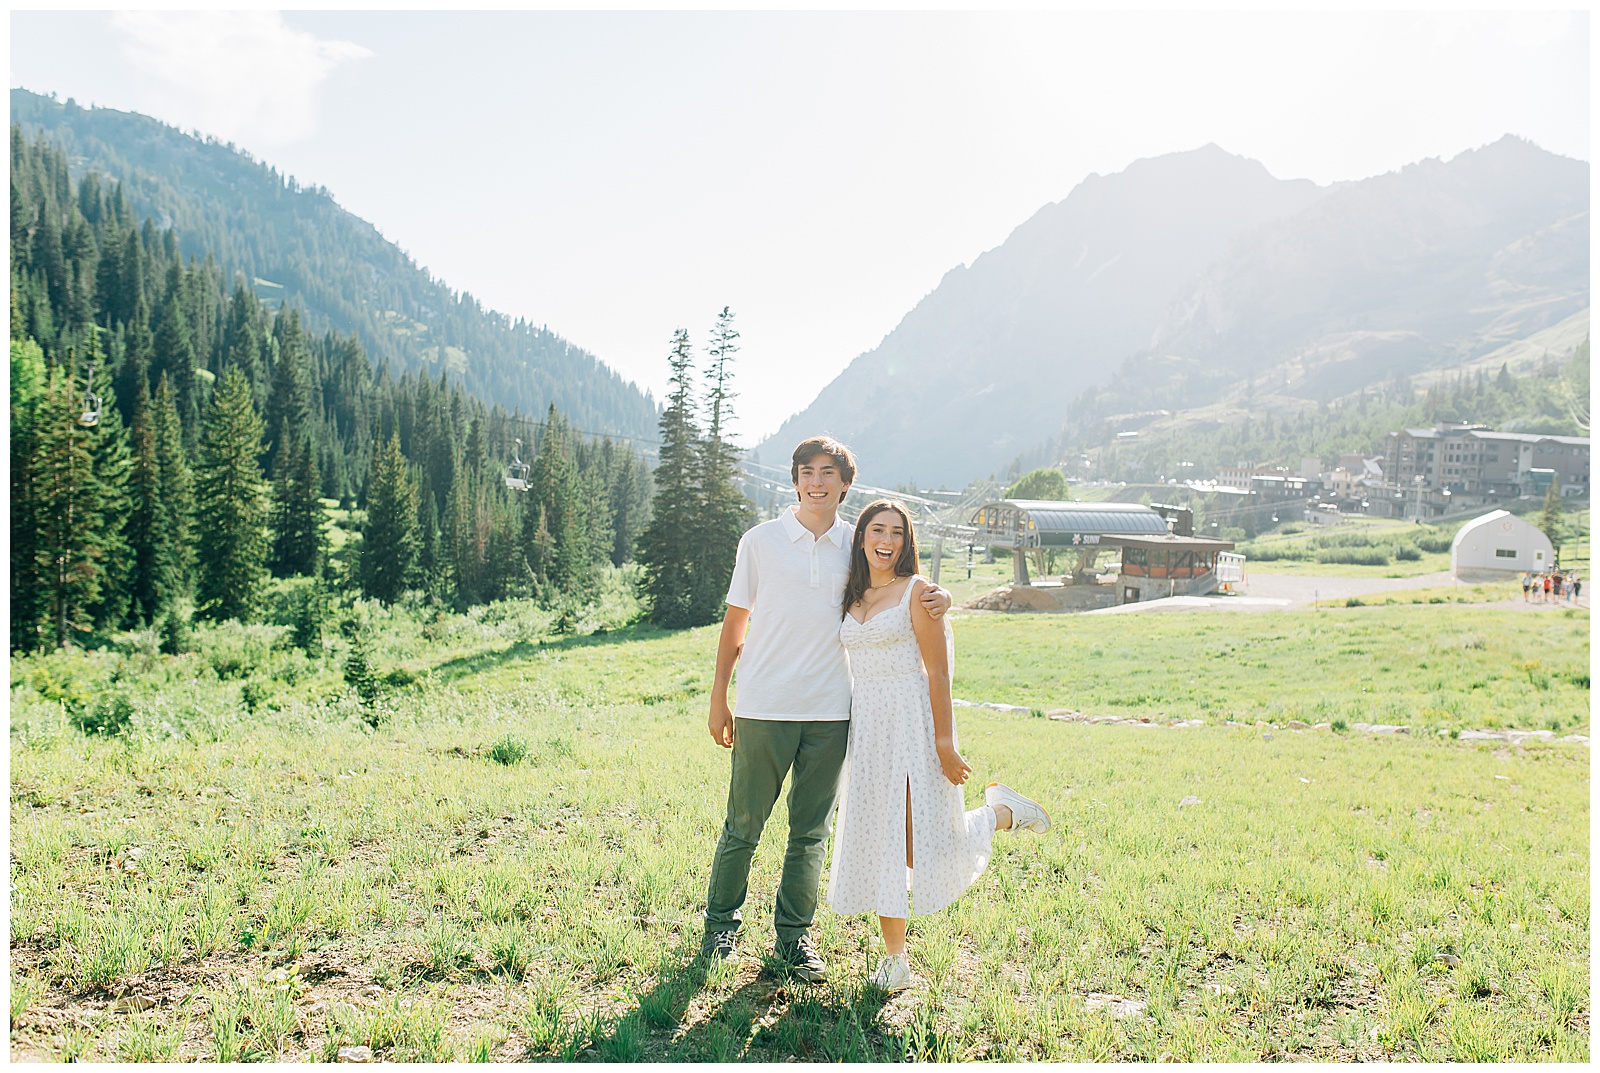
top-left (827, 499), bottom-right (1050, 991)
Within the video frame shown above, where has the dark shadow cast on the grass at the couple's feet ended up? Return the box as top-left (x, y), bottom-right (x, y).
top-left (566, 963), bottom-right (954, 1062)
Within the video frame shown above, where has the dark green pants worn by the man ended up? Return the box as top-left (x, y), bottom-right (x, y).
top-left (706, 720), bottom-right (850, 942)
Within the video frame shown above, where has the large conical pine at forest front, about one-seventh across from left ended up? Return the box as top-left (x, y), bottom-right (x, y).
top-left (195, 369), bottom-right (267, 622)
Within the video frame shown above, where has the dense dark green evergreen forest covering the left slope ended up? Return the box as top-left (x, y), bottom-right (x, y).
top-left (10, 126), bottom-right (650, 649)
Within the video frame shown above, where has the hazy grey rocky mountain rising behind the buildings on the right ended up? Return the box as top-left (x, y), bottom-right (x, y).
top-left (762, 138), bottom-right (1587, 485)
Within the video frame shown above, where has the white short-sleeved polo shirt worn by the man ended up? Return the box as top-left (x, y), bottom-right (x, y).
top-left (728, 507), bottom-right (854, 720)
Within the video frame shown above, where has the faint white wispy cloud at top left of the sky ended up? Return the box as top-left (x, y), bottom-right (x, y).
top-left (110, 11), bottom-right (371, 147)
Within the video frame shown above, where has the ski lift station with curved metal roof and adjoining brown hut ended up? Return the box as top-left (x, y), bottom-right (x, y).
top-left (970, 499), bottom-right (1234, 603)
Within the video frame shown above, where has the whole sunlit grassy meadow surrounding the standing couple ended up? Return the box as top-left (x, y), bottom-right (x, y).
top-left (10, 577), bottom-right (1590, 1062)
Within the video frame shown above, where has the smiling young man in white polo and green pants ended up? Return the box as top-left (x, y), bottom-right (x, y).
top-left (701, 437), bottom-right (950, 980)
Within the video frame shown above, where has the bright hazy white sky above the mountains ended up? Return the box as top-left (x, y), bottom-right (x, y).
top-left (11, 11), bottom-right (1590, 443)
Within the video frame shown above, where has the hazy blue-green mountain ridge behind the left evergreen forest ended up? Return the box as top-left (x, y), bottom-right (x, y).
top-left (10, 88), bottom-right (658, 438)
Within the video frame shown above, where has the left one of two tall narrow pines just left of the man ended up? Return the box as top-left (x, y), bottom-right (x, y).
top-left (638, 328), bottom-right (701, 628)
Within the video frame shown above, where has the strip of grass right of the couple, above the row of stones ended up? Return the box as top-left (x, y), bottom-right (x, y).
top-left (955, 601), bottom-right (1589, 729)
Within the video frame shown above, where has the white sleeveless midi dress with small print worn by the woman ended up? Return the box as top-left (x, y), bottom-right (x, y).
top-left (827, 577), bottom-right (995, 918)
